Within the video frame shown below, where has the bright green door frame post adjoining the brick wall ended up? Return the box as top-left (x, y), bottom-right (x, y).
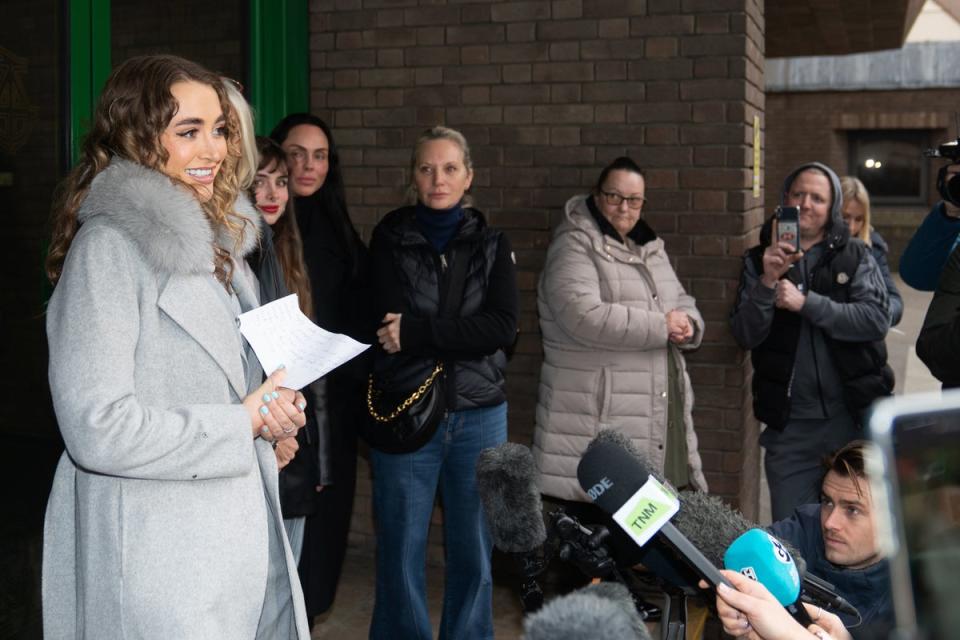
top-left (247, 0), bottom-right (310, 135)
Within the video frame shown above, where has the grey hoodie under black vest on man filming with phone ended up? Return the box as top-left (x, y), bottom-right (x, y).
top-left (730, 162), bottom-right (889, 420)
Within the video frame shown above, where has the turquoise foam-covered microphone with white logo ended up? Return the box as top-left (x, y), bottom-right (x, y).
top-left (723, 529), bottom-right (813, 628)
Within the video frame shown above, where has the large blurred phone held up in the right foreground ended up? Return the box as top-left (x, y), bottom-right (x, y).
top-left (866, 389), bottom-right (960, 640)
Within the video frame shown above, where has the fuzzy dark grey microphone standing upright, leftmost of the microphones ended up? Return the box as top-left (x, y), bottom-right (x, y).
top-left (477, 442), bottom-right (547, 612)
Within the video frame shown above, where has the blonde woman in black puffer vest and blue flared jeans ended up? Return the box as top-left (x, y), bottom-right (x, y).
top-left (370, 127), bottom-right (518, 640)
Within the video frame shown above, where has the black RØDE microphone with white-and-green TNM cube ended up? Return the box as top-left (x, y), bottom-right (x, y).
top-left (577, 441), bottom-right (733, 588)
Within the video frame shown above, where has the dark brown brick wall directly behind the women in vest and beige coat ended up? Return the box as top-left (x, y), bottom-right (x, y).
top-left (310, 0), bottom-right (764, 556)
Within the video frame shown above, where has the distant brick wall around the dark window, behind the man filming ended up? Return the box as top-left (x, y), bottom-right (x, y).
top-left (766, 89), bottom-right (960, 271)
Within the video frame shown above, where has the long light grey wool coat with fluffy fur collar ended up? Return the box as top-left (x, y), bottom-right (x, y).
top-left (43, 159), bottom-right (309, 640)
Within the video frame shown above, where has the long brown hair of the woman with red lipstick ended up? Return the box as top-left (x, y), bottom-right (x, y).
top-left (250, 136), bottom-right (314, 320)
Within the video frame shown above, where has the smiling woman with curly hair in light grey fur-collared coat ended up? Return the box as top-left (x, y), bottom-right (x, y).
top-left (43, 56), bottom-right (309, 640)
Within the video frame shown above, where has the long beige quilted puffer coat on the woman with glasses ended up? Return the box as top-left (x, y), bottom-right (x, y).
top-left (533, 195), bottom-right (707, 501)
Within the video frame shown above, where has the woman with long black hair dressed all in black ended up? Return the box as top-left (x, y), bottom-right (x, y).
top-left (270, 113), bottom-right (370, 617)
